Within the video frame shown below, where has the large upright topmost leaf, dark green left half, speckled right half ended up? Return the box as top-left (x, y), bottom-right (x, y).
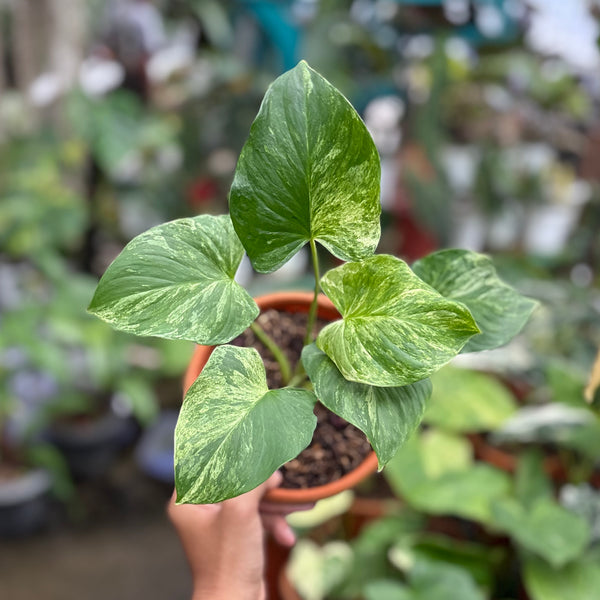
top-left (229, 61), bottom-right (381, 273)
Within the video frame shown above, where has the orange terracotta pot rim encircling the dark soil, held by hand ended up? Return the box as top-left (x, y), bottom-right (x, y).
top-left (183, 292), bottom-right (377, 504)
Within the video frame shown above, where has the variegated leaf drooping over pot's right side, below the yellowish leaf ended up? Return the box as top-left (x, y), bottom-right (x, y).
top-left (302, 344), bottom-right (431, 469)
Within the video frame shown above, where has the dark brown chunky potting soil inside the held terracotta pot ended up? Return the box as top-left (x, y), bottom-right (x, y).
top-left (231, 310), bottom-right (371, 488)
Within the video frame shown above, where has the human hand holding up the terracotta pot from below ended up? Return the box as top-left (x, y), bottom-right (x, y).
top-left (167, 472), bottom-right (311, 600)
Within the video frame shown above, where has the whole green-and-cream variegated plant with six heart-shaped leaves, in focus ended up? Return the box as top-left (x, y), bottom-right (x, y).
top-left (89, 62), bottom-right (535, 503)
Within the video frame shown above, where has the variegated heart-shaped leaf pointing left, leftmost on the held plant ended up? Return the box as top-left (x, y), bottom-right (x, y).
top-left (88, 215), bottom-right (259, 345)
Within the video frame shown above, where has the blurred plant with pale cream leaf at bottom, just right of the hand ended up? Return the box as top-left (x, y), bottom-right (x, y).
top-left (279, 511), bottom-right (493, 600)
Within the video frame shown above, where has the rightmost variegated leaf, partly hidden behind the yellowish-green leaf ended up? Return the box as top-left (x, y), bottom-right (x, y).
top-left (413, 249), bottom-right (537, 352)
